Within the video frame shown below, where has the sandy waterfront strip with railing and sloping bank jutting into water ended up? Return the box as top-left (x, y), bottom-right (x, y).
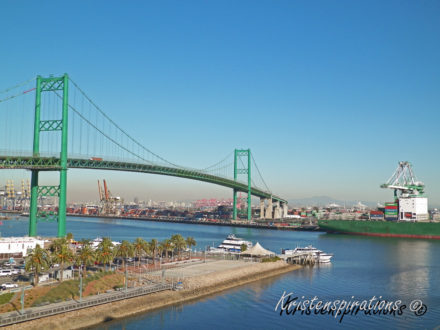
top-left (0, 260), bottom-right (300, 329)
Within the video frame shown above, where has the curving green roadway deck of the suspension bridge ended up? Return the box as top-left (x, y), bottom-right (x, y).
top-left (0, 156), bottom-right (287, 204)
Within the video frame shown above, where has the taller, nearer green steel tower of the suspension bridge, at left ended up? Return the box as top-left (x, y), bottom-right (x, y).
top-left (29, 74), bottom-right (69, 237)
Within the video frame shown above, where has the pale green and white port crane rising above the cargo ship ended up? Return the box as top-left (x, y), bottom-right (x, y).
top-left (380, 162), bottom-right (425, 199)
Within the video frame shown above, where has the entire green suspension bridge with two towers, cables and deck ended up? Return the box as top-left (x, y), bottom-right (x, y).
top-left (0, 74), bottom-right (287, 237)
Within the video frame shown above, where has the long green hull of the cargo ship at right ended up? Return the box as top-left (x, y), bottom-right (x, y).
top-left (318, 220), bottom-right (440, 239)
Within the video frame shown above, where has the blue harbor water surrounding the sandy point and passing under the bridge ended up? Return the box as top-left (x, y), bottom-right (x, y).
top-left (0, 217), bottom-right (440, 330)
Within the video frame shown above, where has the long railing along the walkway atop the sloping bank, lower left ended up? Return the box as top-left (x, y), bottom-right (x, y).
top-left (0, 284), bottom-right (175, 326)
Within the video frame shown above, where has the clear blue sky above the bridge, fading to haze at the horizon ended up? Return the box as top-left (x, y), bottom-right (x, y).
top-left (0, 1), bottom-right (440, 204)
